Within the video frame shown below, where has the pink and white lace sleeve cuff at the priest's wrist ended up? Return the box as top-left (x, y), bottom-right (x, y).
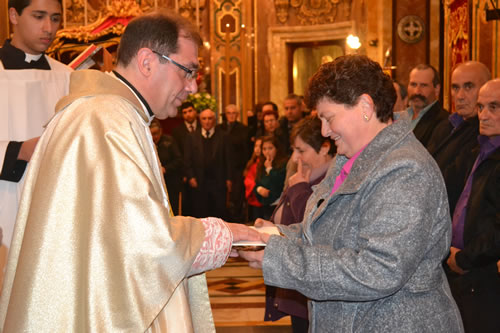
top-left (189, 217), bottom-right (233, 275)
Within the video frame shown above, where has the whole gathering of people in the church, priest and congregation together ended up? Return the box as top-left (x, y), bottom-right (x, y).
top-left (0, 0), bottom-right (500, 332)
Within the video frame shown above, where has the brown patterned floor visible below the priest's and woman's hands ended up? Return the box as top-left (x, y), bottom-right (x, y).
top-left (206, 258), bottom-right (291, 333)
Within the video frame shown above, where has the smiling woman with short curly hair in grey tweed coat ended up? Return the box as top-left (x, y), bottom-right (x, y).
top-left (240, 55), bottom-right (463, 333)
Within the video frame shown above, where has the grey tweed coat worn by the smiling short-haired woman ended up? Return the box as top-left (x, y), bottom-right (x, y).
top-left (263, 118), bottom-right (463, 333)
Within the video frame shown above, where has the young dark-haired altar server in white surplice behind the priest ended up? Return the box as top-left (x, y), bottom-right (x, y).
top-left (0, 0), bottom-right (71, 285)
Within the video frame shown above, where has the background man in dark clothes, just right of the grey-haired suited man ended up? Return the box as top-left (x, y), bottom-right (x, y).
top-left (216, 104), bottom-right (250, 222)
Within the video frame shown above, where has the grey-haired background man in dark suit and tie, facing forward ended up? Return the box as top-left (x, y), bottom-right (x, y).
top-left (184, 109), bottom-right (232, 218)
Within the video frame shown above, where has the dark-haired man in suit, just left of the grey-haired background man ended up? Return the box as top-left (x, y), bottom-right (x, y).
top-left (172, 102), bottom-right (201, 215)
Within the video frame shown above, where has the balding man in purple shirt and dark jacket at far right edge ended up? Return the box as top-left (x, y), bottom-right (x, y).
top-left (447, 79), bottom-right (500, 332)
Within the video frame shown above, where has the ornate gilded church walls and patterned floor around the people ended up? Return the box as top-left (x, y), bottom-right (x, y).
top-left (0, 0), bottom-right (500, 332)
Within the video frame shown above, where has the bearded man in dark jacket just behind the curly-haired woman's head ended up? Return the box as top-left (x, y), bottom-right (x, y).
top-left (407, 65), bottom-right (448, 148)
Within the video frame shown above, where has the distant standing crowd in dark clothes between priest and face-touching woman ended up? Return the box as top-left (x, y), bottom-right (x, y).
top-left (150, 94), bottom-right (309, 223)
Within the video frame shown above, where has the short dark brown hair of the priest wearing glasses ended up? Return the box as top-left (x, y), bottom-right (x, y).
top-left (117, 11), bottom-right (201, 66)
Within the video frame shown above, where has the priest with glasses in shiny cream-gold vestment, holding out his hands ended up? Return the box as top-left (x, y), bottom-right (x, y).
top-left (0, 14), bottom-right (258, 332)
